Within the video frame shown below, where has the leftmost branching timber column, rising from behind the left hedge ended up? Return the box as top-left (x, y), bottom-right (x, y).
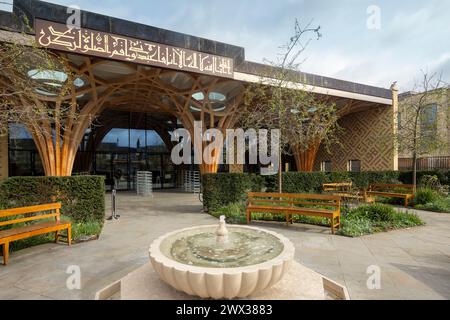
top-left (27, 57), bottom-right (171, 176)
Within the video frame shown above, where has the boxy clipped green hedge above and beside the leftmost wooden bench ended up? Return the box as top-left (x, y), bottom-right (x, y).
top-left (0, 176), bottom-right (105, 224)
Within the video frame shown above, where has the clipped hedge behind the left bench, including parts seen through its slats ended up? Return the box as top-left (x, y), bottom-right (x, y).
top-left (0, 176), bottom-right (105, 251)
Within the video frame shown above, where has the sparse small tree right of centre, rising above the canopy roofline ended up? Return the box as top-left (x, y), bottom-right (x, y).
top-left (240, 20), bottom-right (338, 192)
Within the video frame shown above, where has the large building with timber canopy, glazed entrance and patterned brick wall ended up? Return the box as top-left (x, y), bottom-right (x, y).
top-left (0, 0), bottom-right (398, 189)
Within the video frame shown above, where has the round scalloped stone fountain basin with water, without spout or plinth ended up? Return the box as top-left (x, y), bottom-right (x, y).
top-left (150, 226), bottom-right (295, 299)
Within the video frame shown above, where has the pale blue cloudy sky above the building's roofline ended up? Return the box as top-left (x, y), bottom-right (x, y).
top-left (3, 0), bottom-right (450, 91)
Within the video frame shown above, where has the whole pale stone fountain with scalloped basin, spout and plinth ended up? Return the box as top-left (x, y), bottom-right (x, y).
top-left (96, 217), bottom-right (349, 300)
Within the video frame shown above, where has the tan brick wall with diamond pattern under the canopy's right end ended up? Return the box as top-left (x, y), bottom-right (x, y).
top-left (314, 107), bottom-right (394, 171)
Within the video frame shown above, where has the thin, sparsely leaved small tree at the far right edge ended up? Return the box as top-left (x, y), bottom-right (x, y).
top-left (397, 72), bottom-right (450, 189)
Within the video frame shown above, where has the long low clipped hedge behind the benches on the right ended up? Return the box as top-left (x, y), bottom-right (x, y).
top-left (203, 170), bottom-right (450, 211)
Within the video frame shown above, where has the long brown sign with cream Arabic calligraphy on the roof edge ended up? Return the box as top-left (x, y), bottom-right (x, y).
top-left (35, 19), bottom-right (234, 78)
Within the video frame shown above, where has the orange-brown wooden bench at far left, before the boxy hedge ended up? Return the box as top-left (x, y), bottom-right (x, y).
top-left (0, 203), bottom-right (72, 266)
